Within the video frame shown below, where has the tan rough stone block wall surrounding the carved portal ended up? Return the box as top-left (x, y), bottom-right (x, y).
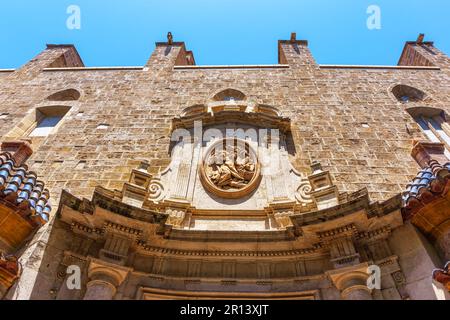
top-left (0, 36), bottom-right (450, 298)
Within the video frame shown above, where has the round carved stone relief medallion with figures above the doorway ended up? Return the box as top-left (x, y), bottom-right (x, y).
top-left (200, 138), bottom-right (261, 199)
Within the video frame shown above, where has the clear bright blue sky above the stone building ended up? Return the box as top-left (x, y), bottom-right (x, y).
top-left (0, 0), bottom-right (450, 68)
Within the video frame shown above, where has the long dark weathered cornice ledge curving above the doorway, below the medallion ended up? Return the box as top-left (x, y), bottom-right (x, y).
top-left (58, 180), bottom-right (398, 248)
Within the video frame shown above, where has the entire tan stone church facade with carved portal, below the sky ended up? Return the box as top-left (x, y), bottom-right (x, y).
top-left (0, 33), bottom-right (450, 300)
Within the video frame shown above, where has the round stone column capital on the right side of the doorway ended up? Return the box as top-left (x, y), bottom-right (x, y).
top-left (327, 263), bottom-right (372, 300)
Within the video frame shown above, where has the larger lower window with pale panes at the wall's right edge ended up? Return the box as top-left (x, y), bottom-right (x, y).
top-left (406, 107), bottom-right (450, 159)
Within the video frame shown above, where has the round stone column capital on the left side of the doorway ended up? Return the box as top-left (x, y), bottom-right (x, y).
top-left (83, 260), bottom-right (130, 300)
